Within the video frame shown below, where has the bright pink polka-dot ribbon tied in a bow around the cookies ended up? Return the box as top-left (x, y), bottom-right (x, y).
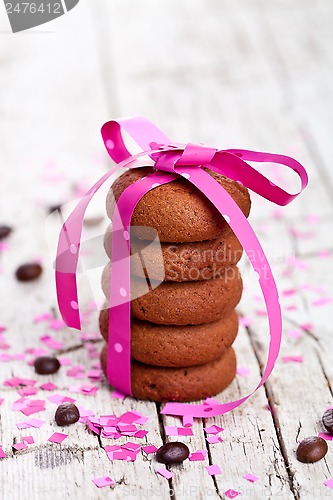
top-left (56, 117), bottom-right (308, 418)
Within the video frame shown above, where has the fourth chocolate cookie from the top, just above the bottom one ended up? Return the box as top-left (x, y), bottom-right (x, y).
top-left (99, 309), bottom-right (238, 367)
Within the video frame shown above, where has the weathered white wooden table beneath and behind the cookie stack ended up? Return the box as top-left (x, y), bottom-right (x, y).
top-left (0, 0), bottom-right (333, 499)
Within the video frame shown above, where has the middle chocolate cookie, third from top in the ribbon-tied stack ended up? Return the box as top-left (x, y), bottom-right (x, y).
top-left (102, 266), bottom-right (243, 325)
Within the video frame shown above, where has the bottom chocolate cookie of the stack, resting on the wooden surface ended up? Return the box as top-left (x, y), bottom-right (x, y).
top-left (101, 344), bottom-right (236, 402)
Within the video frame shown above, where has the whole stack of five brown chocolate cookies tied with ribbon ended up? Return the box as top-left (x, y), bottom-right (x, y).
top-left (100, 167), bottom-right (251, 401)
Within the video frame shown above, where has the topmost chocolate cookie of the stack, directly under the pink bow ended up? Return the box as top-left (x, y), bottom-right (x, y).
top-left (106, 167), bottom-right (251, 243)
